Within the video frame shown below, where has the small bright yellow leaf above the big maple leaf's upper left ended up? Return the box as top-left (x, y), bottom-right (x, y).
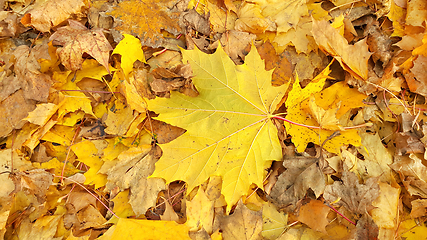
top-left (112, 34), bottom-right (146, 77)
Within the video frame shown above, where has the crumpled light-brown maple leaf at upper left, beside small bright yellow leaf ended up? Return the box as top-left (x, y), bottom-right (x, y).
top-left (49, 20), bottom-right (113, 71)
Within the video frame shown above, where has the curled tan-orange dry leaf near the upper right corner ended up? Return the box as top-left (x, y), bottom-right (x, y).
top-left (312, 19), bottom-right (371, 80)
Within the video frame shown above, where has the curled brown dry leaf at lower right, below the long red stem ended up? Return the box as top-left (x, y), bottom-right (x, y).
top-left (323, 171), bottom-right (379, 216)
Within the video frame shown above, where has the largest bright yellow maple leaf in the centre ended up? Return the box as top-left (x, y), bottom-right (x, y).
top-left (148, 44), bottom-right (287, 209)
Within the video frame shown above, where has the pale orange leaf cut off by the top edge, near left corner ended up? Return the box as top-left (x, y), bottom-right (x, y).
top-left (21, 0), bottom-right (86, 32)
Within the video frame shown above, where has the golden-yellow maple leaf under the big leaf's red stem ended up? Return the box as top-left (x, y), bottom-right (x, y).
top-left (285, 67), bottom-right (364, 154)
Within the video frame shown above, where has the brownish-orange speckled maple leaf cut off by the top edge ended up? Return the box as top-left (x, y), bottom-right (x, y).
top-left (109, 0), bottom-right (181, 47)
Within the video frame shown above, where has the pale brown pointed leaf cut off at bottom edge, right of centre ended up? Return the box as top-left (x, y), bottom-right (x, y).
top-left (219, 200), bottom-right (263, 240)
